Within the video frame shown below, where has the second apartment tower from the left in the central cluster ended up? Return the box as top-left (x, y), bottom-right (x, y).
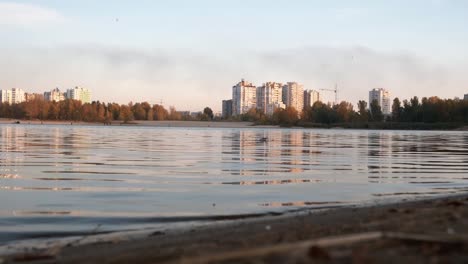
top-left (257, 82), bottom-right (286, 115)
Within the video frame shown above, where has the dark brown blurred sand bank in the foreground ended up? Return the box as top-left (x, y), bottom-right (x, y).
top-left (1, 194), bottom-right (468, 263)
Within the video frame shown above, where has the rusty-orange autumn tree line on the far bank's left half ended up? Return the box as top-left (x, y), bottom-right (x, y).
top-left (0, 99), bottom-right (213, 123)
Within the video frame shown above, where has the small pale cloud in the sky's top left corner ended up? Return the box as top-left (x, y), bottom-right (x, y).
top-left (0, 2), bottom-right (64, 26)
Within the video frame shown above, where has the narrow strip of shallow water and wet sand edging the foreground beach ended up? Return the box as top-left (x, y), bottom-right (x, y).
top-left (0, 192), bottom-right (468, 256)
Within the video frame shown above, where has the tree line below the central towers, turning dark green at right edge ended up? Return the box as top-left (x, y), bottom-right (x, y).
top-left (234, 96), bottom-right (468, 125)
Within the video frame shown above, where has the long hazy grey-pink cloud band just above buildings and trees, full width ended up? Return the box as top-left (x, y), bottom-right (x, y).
top-left (0, 44), bottom-right (468, 110)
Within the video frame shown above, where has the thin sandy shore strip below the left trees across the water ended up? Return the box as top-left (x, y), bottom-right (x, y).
top-left (0, 119), bottom-right (278, 128)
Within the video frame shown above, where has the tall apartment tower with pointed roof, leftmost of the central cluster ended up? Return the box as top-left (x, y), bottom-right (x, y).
top-left (232, 79), bottom-right (257, 116)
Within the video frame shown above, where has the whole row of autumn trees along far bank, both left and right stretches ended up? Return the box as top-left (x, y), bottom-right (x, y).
top-left (0, 96), bottom-right (468, 126)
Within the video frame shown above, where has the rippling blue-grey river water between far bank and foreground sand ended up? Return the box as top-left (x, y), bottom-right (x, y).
top-left (0, 125), bottom-right (468, 243)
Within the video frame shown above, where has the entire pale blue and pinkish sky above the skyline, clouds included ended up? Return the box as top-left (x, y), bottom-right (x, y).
top-left (0, 0), bottom-right (468, 111)
